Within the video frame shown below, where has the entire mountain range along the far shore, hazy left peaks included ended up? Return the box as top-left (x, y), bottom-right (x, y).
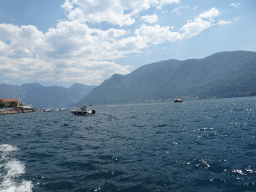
top-left (0, 51), bottom-right (256, 108)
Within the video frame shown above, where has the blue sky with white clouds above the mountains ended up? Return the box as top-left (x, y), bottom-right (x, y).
top-left (0, 0), bottom-right (256, 87)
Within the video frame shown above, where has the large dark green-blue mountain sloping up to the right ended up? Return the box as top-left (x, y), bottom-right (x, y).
top-left (77, 51), bottom-right (256, 104)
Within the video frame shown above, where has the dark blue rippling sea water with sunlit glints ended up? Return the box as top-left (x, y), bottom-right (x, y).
top-left (0, 97), bottom-right (256, 192)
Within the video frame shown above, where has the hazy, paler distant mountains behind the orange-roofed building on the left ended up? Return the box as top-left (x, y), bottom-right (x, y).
top-left (0, 83), bottom-right (96, 108)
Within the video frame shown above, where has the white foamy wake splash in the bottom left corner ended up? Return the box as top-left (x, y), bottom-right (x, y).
top-left (0, 144), bottom-right (33, 192)
